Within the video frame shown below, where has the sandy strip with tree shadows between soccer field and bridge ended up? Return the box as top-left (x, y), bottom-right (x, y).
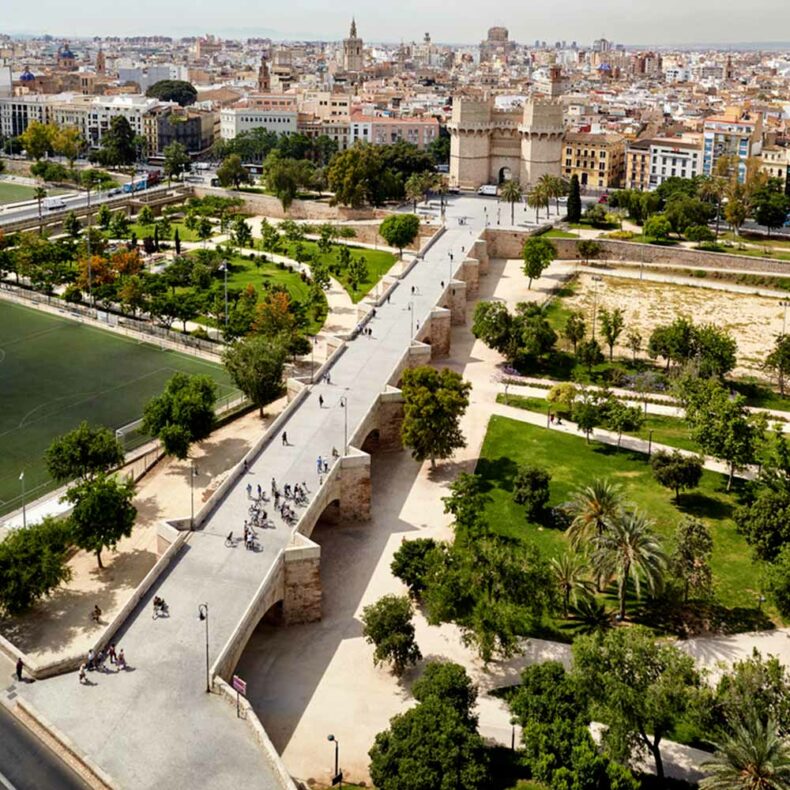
top-left (0, 406), bottom-right (285, 662)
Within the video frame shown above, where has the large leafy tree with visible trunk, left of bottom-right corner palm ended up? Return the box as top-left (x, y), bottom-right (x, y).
top-left (573, 626), bottom-right (700, 783)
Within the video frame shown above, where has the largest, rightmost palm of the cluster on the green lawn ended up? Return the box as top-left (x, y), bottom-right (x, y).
top-left (593, 510), bottom-right (667, 620)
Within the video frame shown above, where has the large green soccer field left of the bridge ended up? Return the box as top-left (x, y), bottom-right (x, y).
top-left (0, 301), bottom-right (235, 514)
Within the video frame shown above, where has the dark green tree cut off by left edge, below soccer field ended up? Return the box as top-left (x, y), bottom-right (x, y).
top-left (0, 516), bottom-right (72, 616)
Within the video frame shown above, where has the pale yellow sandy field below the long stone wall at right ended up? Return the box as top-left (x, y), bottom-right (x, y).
top-left (563, 274), bottom-right (783, 379)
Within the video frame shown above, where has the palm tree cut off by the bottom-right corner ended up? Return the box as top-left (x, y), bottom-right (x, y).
top-left (699, 715), bottom-right (790, 790)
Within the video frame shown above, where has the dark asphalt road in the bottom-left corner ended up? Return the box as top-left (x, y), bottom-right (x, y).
top-left (0, 705), bottom-right (87, 790)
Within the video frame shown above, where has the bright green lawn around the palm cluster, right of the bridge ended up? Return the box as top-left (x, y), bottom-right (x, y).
top-left (477, 416), bottom-right (761, 610)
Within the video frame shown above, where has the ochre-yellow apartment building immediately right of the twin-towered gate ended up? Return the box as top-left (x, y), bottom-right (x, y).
top-left (562, 132), bottom-right (626, 189)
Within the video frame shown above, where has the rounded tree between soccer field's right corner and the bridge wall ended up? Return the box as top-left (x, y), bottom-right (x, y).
top-left (222, 335), bottom-right (288, 417)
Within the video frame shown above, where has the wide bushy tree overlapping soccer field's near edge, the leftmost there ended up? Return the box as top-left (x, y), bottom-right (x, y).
top-left (44, 421), bottom-right (124, 483)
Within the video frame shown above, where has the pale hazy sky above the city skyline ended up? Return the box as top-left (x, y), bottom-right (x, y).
top-left (6, 0), bottom-right (790, 44)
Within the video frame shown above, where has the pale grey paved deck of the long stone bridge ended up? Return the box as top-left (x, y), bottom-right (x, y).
top-left (24, 198), bottom-right (544, 790)
